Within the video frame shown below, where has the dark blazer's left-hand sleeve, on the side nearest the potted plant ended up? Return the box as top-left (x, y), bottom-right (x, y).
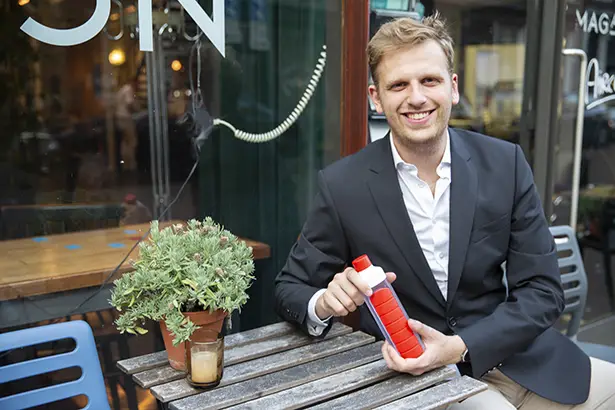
top-left (275, 171), bottom-right (349, 337)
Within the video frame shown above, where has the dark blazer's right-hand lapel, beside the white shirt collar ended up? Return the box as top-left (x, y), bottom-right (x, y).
top-left (446, 128), bottom-right (478, 307)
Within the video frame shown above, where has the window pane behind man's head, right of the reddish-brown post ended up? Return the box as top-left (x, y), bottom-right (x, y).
top-left (369, 0), bottom-right (526, 143)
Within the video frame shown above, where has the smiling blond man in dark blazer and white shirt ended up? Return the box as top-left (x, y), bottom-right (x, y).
top-left (276, 14), bottom-right (615, 410)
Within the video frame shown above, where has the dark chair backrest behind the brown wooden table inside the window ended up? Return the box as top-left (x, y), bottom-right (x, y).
top-left (0, 203), bottom-right (123, 239)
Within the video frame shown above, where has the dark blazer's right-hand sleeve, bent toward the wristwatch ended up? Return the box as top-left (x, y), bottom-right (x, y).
top-left (458, 146), bottom-right (564, 378)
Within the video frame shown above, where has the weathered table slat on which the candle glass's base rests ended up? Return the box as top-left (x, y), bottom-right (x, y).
top-left (152, 332), bottom-right (375, 403)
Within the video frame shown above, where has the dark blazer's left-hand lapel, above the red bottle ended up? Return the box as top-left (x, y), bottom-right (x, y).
top-left (367, 134), bottom-right (446, 307)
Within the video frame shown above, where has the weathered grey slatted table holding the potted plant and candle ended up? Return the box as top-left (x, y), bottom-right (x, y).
top-left (117, 322), bottom-right (487, 410)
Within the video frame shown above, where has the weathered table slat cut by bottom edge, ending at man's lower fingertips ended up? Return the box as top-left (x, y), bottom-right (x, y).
top-left (226, 359), bottom-right (397, 410)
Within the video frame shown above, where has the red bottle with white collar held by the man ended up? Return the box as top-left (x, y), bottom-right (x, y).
top-left (352, 255), bottom-right (425, 359)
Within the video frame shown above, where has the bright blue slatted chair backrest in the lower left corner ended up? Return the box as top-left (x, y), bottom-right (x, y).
top-left (0, 320), bottom-right (110, 410)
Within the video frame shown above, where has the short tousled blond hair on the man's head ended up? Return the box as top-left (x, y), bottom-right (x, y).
top-left (367, 11), bottom-right (455, 85)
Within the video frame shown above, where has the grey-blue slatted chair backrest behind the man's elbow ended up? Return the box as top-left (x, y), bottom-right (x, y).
top-left (549, 225), bottom-right (587, 339)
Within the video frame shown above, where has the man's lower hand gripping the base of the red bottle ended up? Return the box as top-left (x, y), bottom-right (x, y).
top-left (382, 319), bottom-right (466, 376)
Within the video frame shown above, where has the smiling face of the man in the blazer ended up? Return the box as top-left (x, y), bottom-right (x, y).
top-left (369, 40), bottom-right (459, 145)
